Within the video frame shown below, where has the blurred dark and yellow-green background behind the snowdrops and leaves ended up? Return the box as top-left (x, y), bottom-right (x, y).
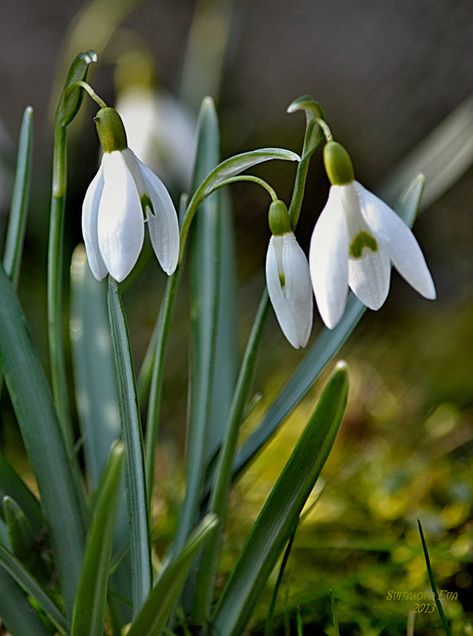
top-left (0, 0), bottom-right (473, 635)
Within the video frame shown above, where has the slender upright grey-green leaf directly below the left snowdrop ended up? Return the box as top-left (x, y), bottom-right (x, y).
top-left (108, 277), bottom-right (151, 616)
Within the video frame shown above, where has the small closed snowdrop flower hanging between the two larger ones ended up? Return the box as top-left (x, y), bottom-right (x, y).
top-left (266, 201), bottom-right (312, 349)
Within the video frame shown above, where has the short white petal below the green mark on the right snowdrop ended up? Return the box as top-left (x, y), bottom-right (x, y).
top-left (348, 244), bottom-right (391, 310)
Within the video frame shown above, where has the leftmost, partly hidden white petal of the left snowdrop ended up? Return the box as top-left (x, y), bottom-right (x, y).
top-left (82, 165), bottom-right (107, 280)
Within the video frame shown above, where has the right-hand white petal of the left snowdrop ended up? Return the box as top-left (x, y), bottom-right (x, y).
top-left (124, 148), bottom-right (179, 275)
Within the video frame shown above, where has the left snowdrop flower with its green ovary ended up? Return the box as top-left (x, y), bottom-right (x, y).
top-left (82, 108), bottom-right (179, 282)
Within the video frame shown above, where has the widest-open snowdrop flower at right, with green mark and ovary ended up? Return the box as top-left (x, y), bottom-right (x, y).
top-left (309, 141), bottom-right (435, 329)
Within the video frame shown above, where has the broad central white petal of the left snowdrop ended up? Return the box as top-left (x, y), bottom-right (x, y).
top-left (98, 151), bottom-right (144, 282)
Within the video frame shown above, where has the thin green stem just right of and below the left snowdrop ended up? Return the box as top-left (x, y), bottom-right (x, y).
top-left (145, 268), bottom-right (182, 509)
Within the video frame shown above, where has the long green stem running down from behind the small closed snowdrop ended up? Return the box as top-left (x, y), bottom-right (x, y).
top-left (196, 289), bottom-right (269, 621)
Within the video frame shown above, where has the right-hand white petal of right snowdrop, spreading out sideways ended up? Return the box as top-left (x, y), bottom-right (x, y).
top-left (356, 183), bottom-right (436, 299)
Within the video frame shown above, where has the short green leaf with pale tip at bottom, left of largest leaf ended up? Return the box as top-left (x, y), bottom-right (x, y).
top-left (128, 515), bottom-right (218, 636)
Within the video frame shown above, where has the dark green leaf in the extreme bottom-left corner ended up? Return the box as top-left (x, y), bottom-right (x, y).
top-left (0, 567), bottom-right (51, 636)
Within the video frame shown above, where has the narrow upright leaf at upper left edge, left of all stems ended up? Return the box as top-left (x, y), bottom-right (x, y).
top-left (3, 106), bottom-right (33, 288)
